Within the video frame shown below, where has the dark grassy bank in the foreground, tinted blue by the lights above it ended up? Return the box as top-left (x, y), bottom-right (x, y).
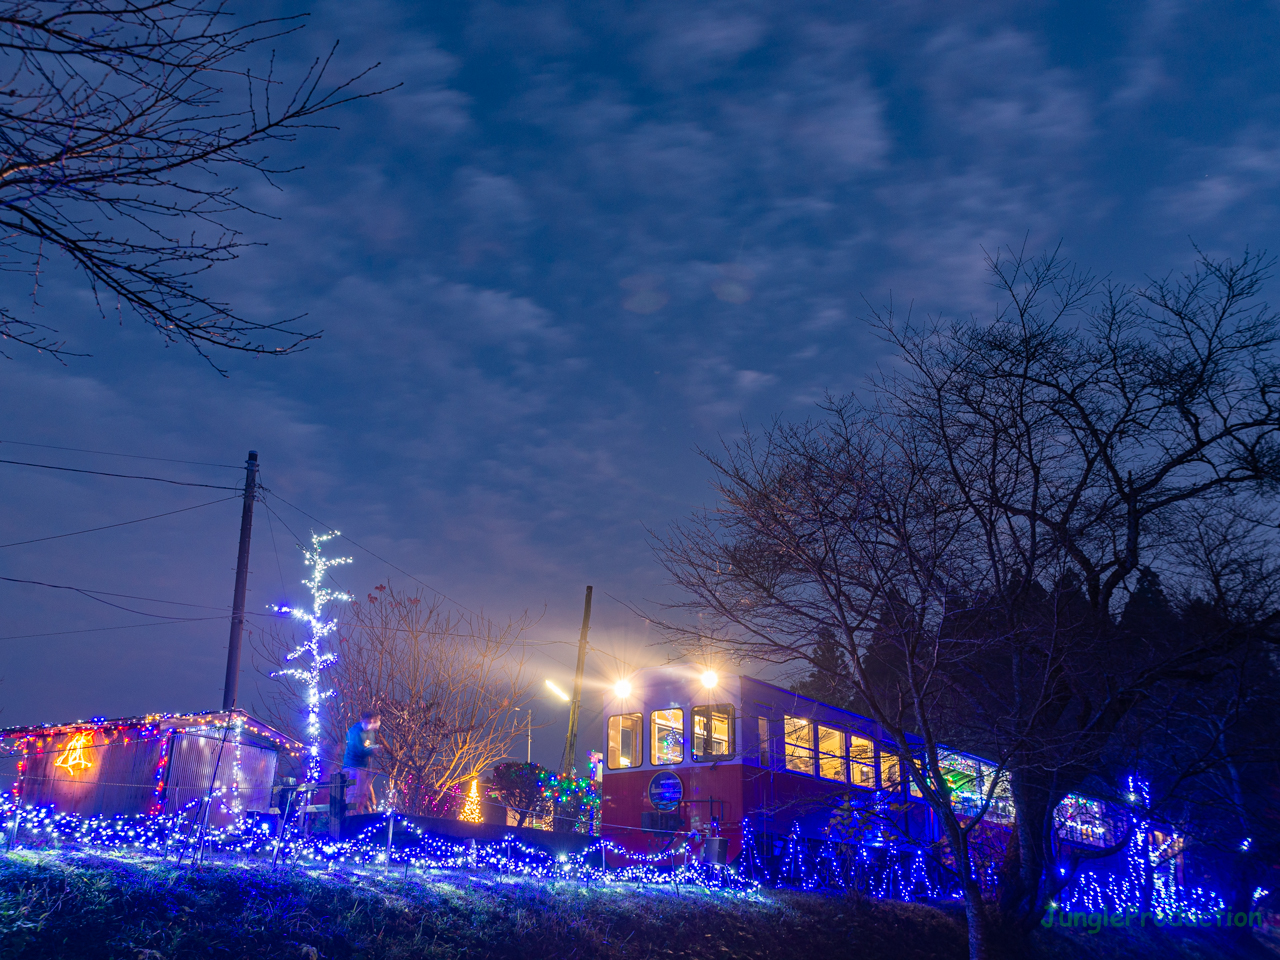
top-left (0, 852), bottom-right (1280, 960)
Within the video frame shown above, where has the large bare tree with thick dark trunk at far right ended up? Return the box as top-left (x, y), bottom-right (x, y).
top-left (877, 244), bottom-right (1280, 928)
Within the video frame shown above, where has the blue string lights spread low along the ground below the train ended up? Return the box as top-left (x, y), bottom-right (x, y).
top-left (0, 777), bottom-right (1233, 919)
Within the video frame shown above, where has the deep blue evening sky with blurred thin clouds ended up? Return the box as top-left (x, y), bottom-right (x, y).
top-left (0, 0), bottom-right (1280, 762)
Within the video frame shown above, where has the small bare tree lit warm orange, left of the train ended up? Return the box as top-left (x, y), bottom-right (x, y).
top-left (256, 585), bottom-right (532, 815)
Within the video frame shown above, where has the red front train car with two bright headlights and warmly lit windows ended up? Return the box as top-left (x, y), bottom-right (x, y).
top-left (600, 666), bottom-right (952, 861)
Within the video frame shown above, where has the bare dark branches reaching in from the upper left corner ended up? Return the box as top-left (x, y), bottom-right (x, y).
top-left (0, 0), bottom-right (389, 368)
